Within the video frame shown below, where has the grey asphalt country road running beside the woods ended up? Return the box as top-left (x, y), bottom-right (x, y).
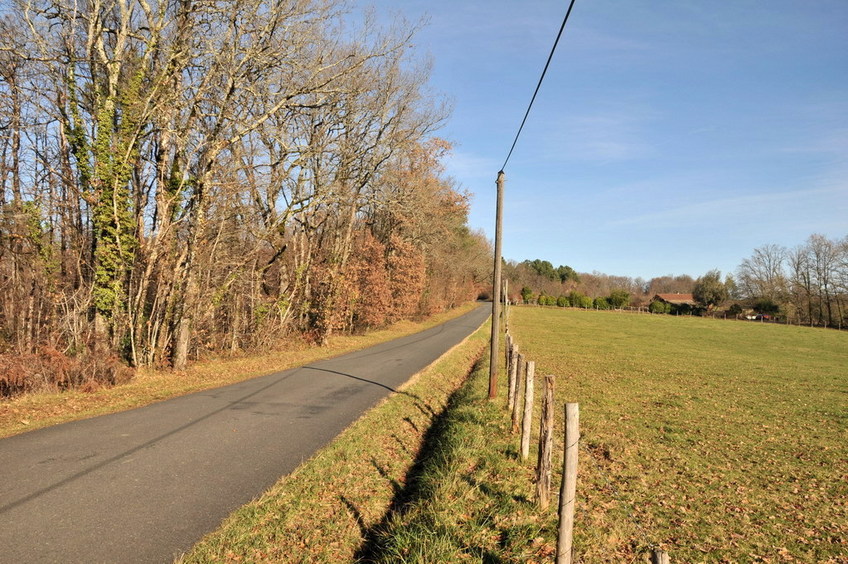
top-left (0, 305), bottom-right (490, 564)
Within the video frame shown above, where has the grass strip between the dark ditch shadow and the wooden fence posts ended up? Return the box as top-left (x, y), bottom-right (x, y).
top-left (348, 334), bottom-right (556, 564)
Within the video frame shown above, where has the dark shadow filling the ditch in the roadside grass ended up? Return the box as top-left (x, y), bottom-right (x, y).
top-left (352, 359), bottom-right (503, 564)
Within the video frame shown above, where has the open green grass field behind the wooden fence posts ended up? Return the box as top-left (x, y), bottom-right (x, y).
top-left (511, 308), bottom-right (848, 562)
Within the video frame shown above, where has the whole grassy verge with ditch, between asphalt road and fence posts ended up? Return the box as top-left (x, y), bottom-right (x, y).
top-left (181, 320), bottom-right (568, 564)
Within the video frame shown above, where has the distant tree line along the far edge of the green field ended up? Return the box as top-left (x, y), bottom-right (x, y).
top-left (505, 234), bottom-right (848, 327)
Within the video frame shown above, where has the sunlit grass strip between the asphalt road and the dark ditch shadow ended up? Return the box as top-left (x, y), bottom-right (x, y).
top-left (182, 318), bottom-right (494, 563)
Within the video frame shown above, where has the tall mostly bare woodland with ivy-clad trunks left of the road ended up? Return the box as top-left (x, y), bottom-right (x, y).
top-left (0, 0), bottom-right (491, 392)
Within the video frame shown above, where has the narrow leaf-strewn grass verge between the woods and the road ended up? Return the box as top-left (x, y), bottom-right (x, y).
top-left (0, 304), bottom-right (475, 438)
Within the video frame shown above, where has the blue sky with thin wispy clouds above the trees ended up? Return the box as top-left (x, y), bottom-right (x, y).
top-left (354, 0), bottom-right (848, 279)
